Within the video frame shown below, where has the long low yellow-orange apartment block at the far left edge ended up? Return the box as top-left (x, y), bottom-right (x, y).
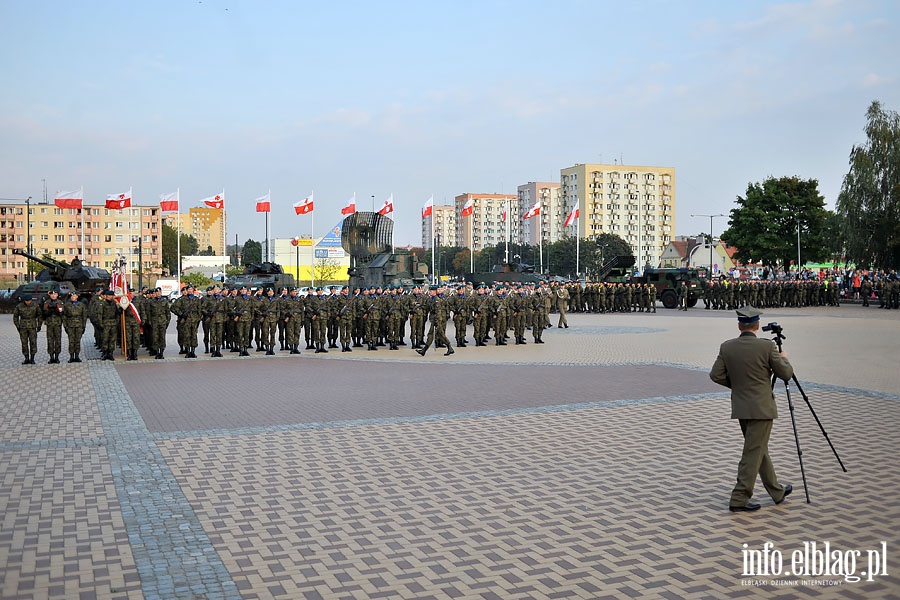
top-left (0, 203), bottom-right (162, 281)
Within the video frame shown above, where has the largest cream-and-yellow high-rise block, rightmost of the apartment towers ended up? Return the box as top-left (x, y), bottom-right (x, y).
top-left (560, 164), bottom-right (675, 269)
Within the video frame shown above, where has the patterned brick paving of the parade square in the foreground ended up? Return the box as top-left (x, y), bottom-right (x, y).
top-left (0, 307), bottom-right (900, 598)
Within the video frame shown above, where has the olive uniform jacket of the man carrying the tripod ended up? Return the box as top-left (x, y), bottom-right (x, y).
top-left (709, 331), bottom-right (794, 419)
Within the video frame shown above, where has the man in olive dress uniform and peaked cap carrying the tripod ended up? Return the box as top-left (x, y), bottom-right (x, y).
top-left (709, 306), bottom-right (794, 512)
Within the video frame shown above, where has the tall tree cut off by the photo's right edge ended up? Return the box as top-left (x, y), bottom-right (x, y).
top-left (836, 101), bottom-right (900, 268)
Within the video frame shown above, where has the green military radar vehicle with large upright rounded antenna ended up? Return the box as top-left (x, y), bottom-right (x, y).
top-left (341, 212), bottom-right (428, 290)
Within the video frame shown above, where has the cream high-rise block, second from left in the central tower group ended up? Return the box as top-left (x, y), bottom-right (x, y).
top-left (454, 194), bottom-right (519, 252)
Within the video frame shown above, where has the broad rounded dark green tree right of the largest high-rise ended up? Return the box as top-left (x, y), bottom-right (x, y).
top-left (722, 177), bottom-right (829, 267)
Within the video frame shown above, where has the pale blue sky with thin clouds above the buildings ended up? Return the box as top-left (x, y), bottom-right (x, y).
top-left (0, 0), bottom-right (900, 246)
